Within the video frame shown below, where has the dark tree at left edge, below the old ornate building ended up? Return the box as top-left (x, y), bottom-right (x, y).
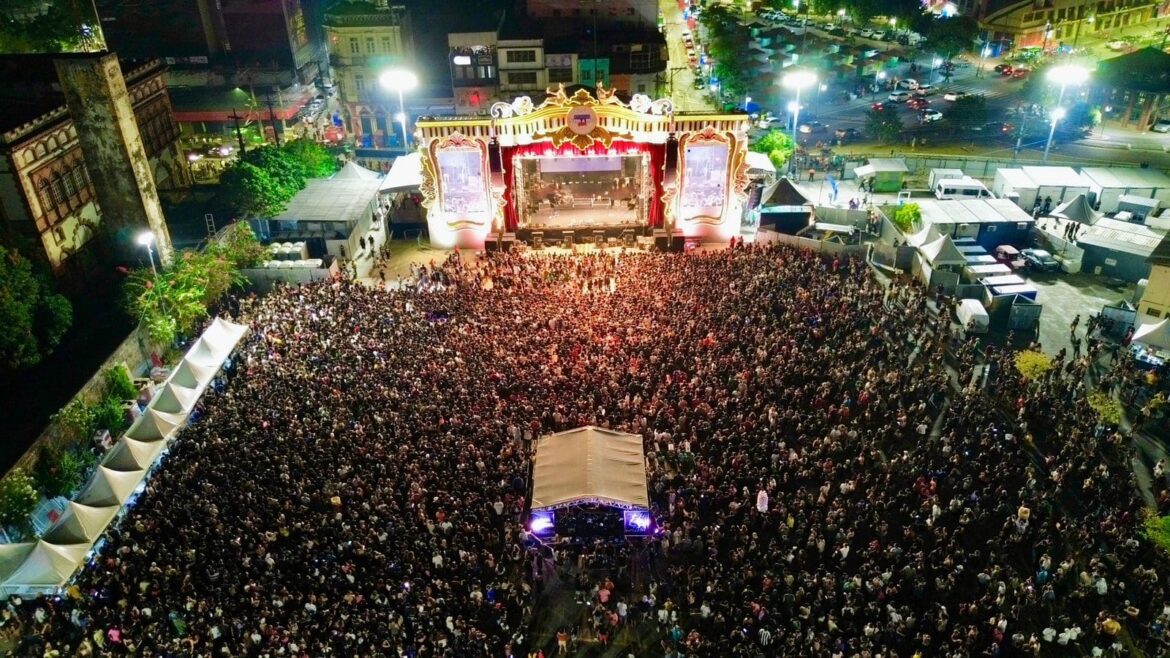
top-left (0, 247), bottom-right (73, 370)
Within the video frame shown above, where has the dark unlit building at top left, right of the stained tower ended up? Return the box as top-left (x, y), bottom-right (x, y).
top-left (94, 0), bottom-right (326, 88)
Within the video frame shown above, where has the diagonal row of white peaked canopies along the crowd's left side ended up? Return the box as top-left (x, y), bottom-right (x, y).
top-left (0, 317), bottom-right (248, 596)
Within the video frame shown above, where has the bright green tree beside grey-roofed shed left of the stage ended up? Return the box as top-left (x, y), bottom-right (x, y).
top-left (220, 139), bottom-right (337, 218)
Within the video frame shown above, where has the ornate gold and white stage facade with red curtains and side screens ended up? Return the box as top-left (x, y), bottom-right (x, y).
top-left (415, 85), bottom-right (749, 248)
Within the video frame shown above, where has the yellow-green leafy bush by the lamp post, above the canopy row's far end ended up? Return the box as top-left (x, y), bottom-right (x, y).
top-left (124, 251), bottom-right (246, 345)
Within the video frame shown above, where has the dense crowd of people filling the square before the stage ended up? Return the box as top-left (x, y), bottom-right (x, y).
top-left (9, 246), bottom-right (1170, 658)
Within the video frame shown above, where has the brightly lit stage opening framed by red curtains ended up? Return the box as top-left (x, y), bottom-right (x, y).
top-left (514, 153), bottom-right (651, 229)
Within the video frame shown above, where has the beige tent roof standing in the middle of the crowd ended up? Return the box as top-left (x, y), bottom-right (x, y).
top-left (532, 426), bottom-right (649, 509)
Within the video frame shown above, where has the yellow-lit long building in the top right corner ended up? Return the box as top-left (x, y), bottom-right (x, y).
top-left (978, 0), bottom-right (1163, 49)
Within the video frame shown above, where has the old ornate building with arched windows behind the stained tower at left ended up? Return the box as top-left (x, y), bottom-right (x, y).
top-left (0, 55), bottom-right (191, 284)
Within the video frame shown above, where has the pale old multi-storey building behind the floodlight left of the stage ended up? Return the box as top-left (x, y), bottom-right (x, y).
top-left (325, 1), bottom-right (414, 149)
